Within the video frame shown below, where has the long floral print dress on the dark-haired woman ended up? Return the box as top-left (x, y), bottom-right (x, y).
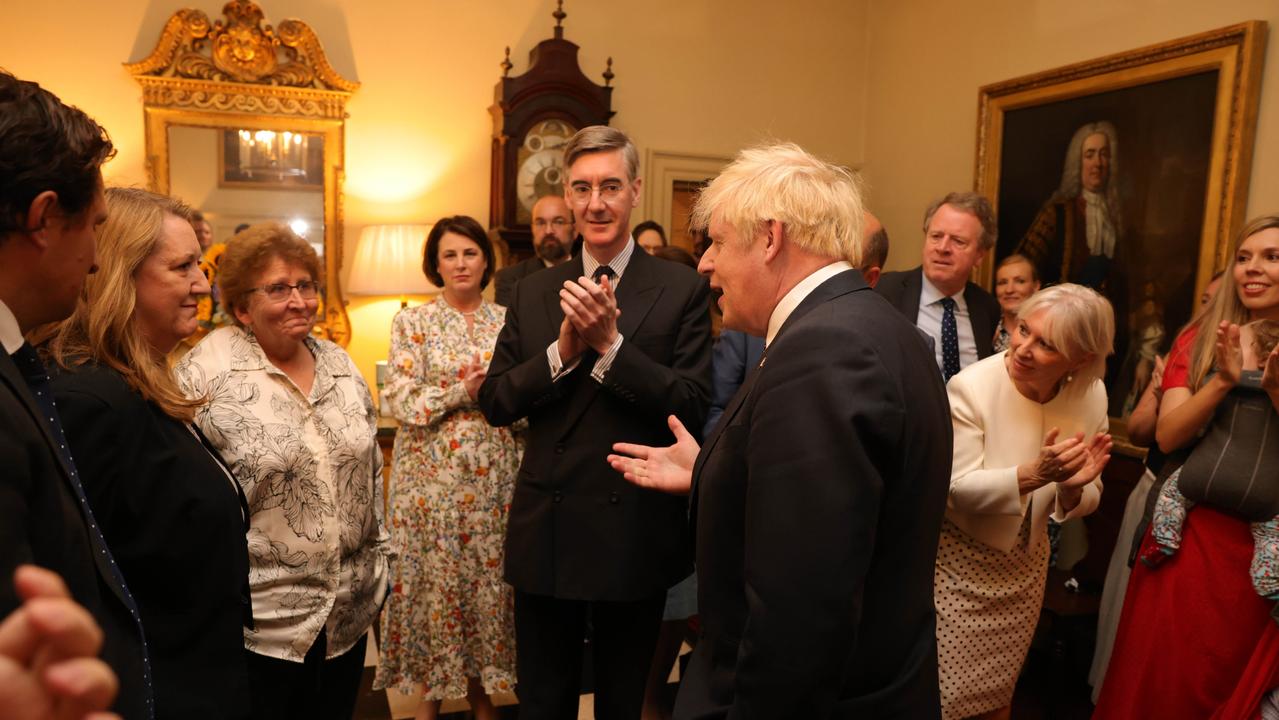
top-left (373, 298), bottom-right (523, 700)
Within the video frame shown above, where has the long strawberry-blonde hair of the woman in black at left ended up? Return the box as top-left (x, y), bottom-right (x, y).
top-left (49, 188), bottom-right (205, 422)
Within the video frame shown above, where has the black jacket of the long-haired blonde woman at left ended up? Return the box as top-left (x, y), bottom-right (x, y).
top-left (54, 364), bottom-right (252, 720)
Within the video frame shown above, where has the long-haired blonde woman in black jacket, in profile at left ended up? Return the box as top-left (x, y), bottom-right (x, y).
top-left (47, 188), bottom-right (249, 720)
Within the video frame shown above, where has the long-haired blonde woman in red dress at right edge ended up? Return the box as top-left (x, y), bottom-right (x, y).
top-left (1092, 214), bottom-right (1279, 720)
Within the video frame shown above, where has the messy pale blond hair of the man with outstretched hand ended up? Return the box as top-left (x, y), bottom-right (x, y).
top-left (692, 142), bottom-right (865, 267)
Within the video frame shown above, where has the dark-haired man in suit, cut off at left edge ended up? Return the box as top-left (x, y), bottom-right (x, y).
top-left (0, 72), bottom-right (151, 720)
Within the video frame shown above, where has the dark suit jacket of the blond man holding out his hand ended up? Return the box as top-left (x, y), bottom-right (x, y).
top-left (675, 270), bottom-right (952, 720)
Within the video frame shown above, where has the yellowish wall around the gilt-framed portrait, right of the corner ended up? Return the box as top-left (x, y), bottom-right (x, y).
top-left (863, 0), bottom-right (1279, 270)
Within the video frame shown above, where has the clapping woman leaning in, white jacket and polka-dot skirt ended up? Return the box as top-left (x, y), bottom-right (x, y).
top-left (935, 284), bottom-right (1114, 720)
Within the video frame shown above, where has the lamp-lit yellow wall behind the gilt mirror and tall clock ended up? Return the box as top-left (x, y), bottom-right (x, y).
top-left (0, 0), bottom-right (868, 388)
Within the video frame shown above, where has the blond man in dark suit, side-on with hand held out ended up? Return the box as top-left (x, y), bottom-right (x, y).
top-left (609, 145), bottom-right (952, 720)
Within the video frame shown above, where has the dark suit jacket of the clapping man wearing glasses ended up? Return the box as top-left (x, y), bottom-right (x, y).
top-left (480, 249), bottom-right (711, 601)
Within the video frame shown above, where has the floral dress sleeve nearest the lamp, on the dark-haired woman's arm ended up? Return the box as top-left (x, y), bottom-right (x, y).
top-left (382, 308), bottom-right (472, 426)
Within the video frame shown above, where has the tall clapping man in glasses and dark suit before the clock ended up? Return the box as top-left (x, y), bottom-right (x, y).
top-left (478, 125), bottom-right (711, 720)
